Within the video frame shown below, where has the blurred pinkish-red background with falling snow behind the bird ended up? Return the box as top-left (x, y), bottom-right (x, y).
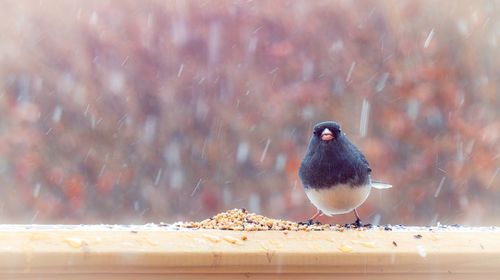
top-left (0, 0), bottom-right (500, 225)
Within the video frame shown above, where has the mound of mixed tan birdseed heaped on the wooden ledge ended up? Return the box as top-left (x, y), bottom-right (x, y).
top-left (174, 209), bottom-right (355, 231)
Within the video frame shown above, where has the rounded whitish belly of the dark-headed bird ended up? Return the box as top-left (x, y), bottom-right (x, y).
top-left (305, 185), bottom-right (371, 216)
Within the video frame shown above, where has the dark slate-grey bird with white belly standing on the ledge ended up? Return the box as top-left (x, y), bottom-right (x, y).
top-left (298, 121), bottom-right (392, 226)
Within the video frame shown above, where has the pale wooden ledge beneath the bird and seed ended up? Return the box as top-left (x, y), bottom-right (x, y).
top-left (0, 225), bottom-right (500, 279)
